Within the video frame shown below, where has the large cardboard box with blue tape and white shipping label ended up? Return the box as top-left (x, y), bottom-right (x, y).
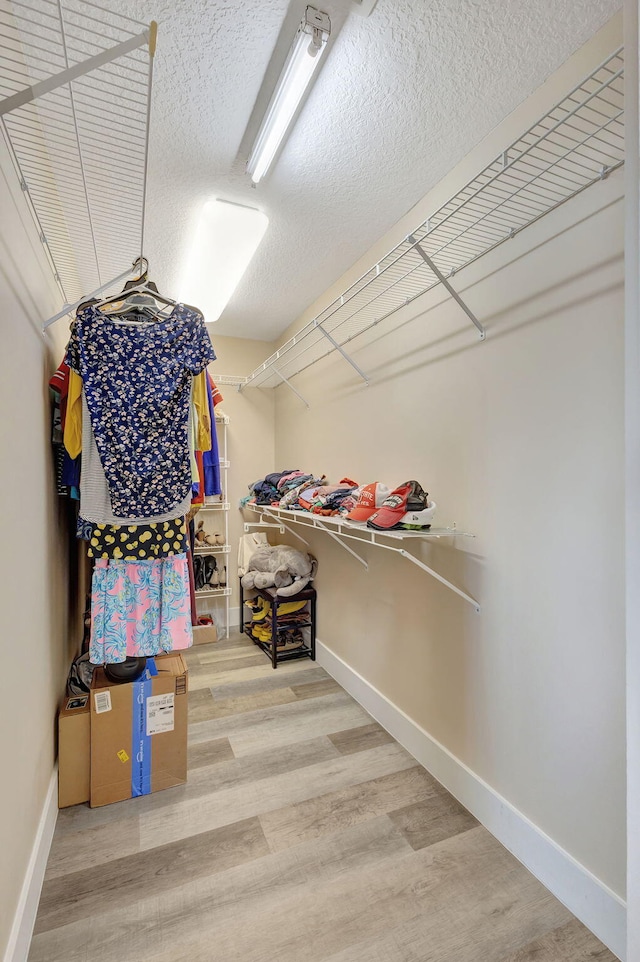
top-left (90, 652), bottom-right (188, 808)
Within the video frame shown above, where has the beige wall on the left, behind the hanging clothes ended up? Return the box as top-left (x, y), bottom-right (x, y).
top-left (0, 140), bottom-right (73, 959)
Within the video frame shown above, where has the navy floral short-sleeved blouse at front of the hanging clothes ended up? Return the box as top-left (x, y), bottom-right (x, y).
top-left (65, 304), bottom-right (216, 518)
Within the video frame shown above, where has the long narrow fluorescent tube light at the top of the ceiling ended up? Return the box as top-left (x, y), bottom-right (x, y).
top-left (247, 7), bottom-right (331, 184)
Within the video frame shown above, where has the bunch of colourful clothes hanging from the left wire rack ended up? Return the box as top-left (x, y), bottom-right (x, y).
top-left (51, 284), bottom-right (218, 664)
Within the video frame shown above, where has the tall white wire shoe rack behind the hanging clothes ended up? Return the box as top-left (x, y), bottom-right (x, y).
top-left (193, 415), bottom-right (231, 638)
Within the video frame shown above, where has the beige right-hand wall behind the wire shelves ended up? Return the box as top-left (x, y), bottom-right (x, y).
top-left (258, 11), bottom-right (626, 944)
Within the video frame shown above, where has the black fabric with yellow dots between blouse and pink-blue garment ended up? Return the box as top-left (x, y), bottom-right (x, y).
top-left (88, 518), bottom-right (187, 561)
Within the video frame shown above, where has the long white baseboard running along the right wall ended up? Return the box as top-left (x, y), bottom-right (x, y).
top-left (317, 641), bottom-right (626, 960)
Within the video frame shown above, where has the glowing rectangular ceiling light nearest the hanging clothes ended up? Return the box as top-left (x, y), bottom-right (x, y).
top-left (180, 200), bottom-right (269, 322)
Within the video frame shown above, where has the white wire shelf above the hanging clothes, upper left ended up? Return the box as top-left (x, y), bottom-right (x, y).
top-left (0, 0), bottom-right (156, 320)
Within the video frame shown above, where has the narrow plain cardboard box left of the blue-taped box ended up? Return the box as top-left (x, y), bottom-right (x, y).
top-left (58, 695), bottom-right (91, 808)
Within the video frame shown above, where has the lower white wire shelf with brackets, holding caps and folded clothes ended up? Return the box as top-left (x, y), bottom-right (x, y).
top-left (243, 504), bottom-right (480, 611)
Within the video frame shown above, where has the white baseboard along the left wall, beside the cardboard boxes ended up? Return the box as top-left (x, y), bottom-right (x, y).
top-left (4, 763), bottom-right (58, 962)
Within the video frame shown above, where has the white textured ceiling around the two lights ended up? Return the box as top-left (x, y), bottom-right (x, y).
top-left (63, 0), bottom-right (619, 341)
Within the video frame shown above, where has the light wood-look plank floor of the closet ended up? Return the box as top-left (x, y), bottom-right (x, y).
top-left (29, 634), bottom-right (615, 962)
